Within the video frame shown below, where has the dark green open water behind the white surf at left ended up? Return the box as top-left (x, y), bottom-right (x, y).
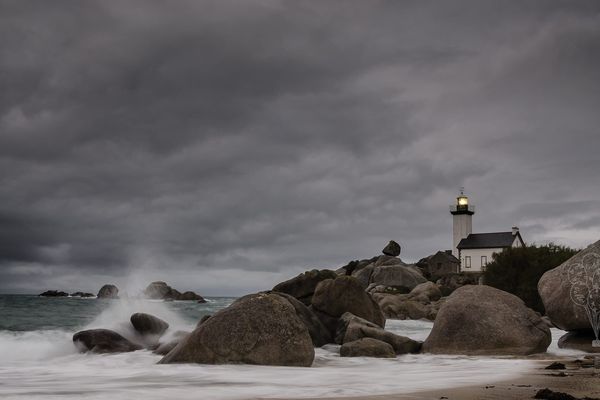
top-left (0, 295), bottom-right (235, 331)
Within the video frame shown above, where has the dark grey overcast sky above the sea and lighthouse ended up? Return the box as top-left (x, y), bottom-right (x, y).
top-left (0, 0), bottom-right (600, 295)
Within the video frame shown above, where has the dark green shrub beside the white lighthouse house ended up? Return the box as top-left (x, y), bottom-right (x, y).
top-left (483, 243), bottom-right (579, 314)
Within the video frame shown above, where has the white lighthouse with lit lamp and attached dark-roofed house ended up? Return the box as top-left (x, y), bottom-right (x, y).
top-left (450, 190), bottom-right (525, 272)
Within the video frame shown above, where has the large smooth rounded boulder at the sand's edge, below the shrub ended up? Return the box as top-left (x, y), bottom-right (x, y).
top-left (423, 285), bottom-right (551, 355)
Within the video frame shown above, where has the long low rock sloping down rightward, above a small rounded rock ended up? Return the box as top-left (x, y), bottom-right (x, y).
top-left (335, 313), bottom-right (421, 354)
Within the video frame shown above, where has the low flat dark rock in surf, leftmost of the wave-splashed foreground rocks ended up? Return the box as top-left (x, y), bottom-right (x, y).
top-left (73, 329), bottom-right (142, 353)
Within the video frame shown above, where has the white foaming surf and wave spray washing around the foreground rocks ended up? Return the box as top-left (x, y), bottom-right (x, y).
top-left (0, 318), bottom-right (552, 400)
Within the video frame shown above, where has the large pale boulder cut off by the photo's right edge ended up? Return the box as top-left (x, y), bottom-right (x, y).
top-left (538, 241), bottom-right (600, 331)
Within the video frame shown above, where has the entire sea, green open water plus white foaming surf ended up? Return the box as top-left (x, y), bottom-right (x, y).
top-left (0, 295), bottom-right (579, 400)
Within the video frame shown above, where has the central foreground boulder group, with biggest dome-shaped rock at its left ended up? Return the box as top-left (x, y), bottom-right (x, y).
top-left (160, 271), bottom-right (421, 366)
